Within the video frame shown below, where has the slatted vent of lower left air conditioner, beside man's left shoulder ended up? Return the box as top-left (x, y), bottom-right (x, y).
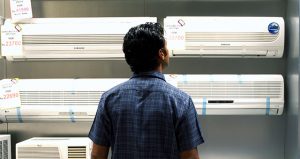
top-left (20, 91), bottom-right (103, 106)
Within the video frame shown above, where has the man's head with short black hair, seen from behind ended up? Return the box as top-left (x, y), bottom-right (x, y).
top-left (123, 23), bottom-right (169, 73)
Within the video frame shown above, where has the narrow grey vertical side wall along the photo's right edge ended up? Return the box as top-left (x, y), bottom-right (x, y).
top-left (285, 0), bottom-right (300, 159)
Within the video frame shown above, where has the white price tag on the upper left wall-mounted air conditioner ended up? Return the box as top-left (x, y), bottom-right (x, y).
top-left (1, 24), bottom-right (23, 56)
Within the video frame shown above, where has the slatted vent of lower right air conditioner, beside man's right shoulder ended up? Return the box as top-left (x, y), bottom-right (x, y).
top-left (178, 81), bottom-right (283, 99)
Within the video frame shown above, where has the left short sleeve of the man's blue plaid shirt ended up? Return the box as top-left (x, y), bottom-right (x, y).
top-left (88, 95), bottom-right (111, 147)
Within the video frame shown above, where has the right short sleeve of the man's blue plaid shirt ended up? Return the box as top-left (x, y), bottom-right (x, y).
top-left (176, 98), bottom-right (204, 152)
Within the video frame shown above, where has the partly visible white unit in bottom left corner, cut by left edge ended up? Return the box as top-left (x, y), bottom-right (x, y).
top-left (0, 134), bottom-right (11, 159)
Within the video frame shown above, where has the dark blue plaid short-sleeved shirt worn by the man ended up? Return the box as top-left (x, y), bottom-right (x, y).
top-left (89, 72), bottom-right (204, 159)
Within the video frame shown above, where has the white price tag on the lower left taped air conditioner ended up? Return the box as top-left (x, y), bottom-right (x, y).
top-left (0, 79), bottom-right (21, 110)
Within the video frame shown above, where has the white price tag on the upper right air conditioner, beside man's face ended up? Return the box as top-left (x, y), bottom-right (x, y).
top-left (165, 19), bottom-right (185, 50)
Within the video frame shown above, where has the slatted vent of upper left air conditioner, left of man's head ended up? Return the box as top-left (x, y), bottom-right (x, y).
top-left (23, 34), bottom-right (124, 45)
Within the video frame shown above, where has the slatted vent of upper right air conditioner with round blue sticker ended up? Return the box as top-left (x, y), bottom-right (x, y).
top-left (185, 32), bottom-right (278, 43)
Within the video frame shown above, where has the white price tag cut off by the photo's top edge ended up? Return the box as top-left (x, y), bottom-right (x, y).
top-left (10, 0), bottom-right (32, 19)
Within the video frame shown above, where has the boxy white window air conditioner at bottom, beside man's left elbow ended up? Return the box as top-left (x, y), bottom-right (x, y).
top-left (16, 137), bottom-right (91, 159)
